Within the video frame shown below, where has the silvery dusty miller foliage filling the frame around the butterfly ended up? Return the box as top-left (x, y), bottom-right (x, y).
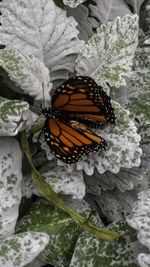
top-left (0, 0), bottom-right (150, 267)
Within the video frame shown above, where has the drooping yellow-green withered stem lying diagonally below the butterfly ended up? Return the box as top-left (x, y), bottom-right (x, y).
top-left (21, 132), bottom-right (120, 240)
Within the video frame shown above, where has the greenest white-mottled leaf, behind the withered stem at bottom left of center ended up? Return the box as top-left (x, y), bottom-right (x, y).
top-left (17, 201), bottom-right (81, 266)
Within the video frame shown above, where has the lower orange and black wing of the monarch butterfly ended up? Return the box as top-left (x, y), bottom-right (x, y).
top-left (44, 118), bottom-right (107, 164)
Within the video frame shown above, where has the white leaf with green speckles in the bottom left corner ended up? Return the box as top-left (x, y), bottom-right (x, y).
top-left (0, 232), bottom-right (49, 267)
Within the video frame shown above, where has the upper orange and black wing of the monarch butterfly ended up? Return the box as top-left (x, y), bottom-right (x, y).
top-left (52, 76), bottom-right (115, 128)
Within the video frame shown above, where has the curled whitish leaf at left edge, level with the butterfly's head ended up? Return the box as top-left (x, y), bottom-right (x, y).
top-left (0, 97), bottom-right (36, 136)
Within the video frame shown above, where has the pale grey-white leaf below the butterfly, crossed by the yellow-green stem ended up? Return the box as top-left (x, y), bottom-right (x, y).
top-left (22, 161), bottom-right (85, 199)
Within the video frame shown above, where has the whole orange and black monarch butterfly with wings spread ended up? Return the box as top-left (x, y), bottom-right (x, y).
top-left (42, 76), bottom-right (115, 164)
